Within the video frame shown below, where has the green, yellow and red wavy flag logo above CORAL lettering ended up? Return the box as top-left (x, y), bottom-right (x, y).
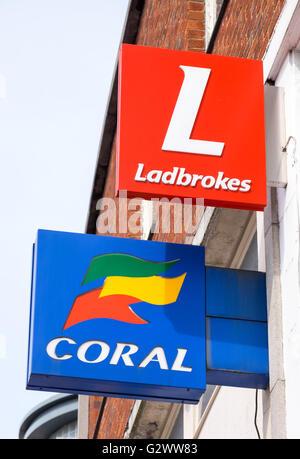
top-left (63, 253), bottom-right (186, 330)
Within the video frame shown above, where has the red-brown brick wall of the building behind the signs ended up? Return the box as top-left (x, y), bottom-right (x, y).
top-left (89, 0), bottom-right (284, 439)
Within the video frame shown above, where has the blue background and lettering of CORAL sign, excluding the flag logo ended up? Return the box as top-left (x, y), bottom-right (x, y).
top-left (27, 230), bottom-right (206, 403)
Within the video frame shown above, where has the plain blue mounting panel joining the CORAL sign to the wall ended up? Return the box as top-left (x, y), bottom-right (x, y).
top-left (206, 267), bottom-right (269, 389)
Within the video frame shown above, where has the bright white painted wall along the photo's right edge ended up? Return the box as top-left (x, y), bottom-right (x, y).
top-left (276, 51), bottom-right (300, 438)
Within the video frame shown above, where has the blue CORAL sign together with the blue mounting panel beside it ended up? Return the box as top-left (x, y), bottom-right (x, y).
top-left (27, 230), bottom-right (268, 403)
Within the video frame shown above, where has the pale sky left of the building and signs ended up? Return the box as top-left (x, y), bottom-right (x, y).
top-left (0, 0), bottom-right (129, 439)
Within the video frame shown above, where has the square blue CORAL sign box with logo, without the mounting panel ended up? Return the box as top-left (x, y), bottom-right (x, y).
top-left (27, 230), bottom-right (206, 403)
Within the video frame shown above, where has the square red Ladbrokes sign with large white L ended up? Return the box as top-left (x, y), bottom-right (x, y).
top-left (116, 45), bottom-right (266, 210)
